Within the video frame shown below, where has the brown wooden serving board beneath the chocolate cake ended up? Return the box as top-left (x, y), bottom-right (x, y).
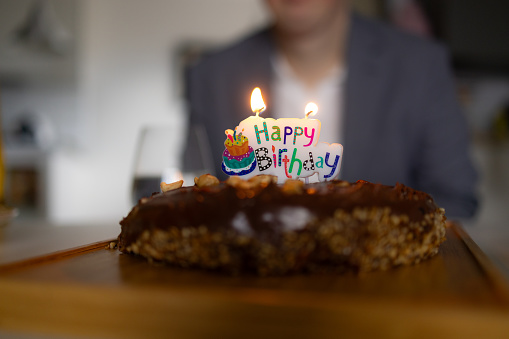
top-left (0, 225), bottom-right (509, 339)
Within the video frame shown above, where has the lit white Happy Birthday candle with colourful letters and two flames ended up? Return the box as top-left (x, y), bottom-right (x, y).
top-left (222, 87), bottom-right (343, 182)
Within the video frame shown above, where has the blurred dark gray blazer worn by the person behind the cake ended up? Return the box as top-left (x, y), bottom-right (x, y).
top-left (184, 14), bottom-right (477, 218)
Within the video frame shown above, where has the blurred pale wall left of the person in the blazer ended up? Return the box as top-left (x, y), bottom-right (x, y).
top-left (0, 0), bottom-right (266, 224)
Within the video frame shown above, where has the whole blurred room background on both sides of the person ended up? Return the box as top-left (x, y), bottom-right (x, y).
top-left (0, 0), bottom-right (509, 231)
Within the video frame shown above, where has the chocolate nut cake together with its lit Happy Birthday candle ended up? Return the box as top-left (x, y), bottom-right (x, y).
top-left (118, 89), bottom-right (446, 275)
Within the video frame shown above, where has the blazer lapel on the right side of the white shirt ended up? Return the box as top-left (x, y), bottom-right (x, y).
top-left (341, 14), bottom-right (383, 181)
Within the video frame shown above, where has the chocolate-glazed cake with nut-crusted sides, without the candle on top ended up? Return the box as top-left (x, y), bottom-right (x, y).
top-left (118, 175), bottom-right (446, 275)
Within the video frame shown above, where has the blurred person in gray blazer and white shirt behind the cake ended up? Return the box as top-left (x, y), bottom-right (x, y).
top-left (184, 0), bottom-right (478, 219)
